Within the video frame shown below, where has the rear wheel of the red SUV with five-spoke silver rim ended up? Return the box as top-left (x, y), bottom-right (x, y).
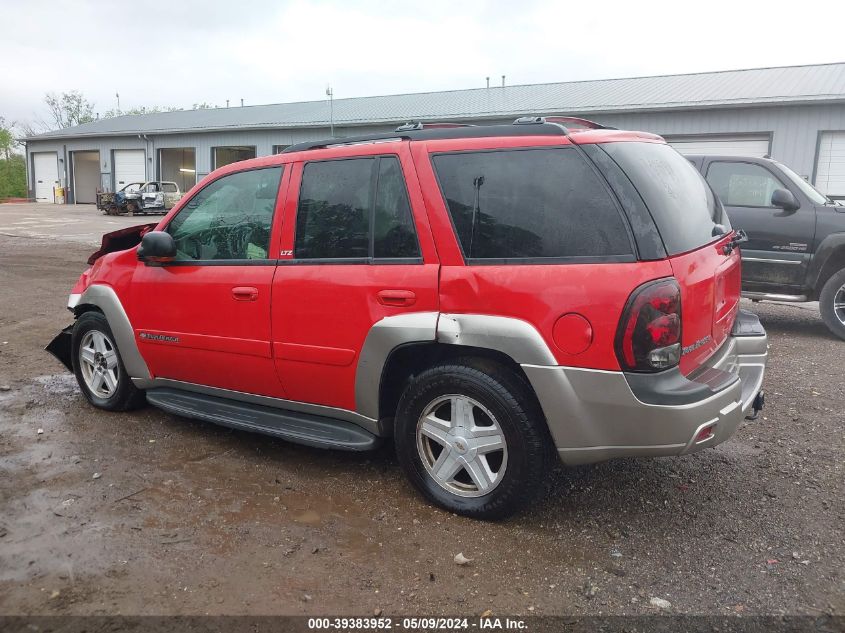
top-left (394, 359), bottom-right (553, 519)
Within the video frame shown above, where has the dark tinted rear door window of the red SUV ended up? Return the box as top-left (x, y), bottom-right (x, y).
top-left (294, 156), bottom-right (420, 263)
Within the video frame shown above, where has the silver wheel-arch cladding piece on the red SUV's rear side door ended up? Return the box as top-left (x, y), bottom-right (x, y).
top-left (355, 312), bottom-right (438, 420)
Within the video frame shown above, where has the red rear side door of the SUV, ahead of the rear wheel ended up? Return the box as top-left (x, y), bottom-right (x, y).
top-left (272, 149), bottom-right (439, 411)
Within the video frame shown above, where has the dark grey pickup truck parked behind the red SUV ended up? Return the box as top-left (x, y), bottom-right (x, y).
top-left (687, 156), bottom-right (845, 339)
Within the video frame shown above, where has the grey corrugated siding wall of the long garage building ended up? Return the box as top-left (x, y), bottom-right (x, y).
top-left (27, 104), bottom-right (845, 202)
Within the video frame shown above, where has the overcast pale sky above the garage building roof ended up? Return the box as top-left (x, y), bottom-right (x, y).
top-left (0, 0), bottom-right (845, 129)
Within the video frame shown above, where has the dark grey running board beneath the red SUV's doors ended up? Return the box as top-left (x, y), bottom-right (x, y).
top-left (147, 388), bottom-right (381, 451)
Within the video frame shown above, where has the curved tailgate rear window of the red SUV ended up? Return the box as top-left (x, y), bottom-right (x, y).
top-left (600, 142), bottom-right (731, 255)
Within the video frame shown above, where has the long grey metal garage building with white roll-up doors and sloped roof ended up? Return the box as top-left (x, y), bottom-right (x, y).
top-left (25, 63), bottom-right (845, 202)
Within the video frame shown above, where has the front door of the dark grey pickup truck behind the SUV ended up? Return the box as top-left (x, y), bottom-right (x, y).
top-left (706, 160), bottom-right (815, 289)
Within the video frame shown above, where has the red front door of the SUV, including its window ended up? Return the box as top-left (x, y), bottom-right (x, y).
top-left (130, 166), bottom-right (284, 397)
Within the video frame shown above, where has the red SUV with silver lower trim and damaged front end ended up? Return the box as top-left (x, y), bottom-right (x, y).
top-left (48, 117), bottom-right (767, 518)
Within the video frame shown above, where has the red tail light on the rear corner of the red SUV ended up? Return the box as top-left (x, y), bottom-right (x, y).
top-left (616, 278), bottom-right (681, 372)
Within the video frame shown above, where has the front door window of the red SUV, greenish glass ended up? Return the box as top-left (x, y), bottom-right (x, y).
top-left (166, 167), bottom-right (282, 261)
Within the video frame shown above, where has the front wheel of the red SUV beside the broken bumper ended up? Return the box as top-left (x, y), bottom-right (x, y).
top-left (71, 312), bottom-right (145, 411)
